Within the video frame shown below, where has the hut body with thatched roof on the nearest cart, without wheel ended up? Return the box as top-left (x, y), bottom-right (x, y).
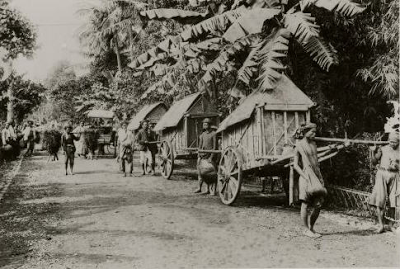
top-left (217, 75), bottom-right (314, 169)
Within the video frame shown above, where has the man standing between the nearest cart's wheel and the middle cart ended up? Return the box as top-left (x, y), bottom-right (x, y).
top-left (195, 118), bottom-right (217, 194)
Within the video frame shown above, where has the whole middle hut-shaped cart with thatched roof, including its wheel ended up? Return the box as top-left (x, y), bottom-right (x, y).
top-left (154, 93), bottom-right (220, 179)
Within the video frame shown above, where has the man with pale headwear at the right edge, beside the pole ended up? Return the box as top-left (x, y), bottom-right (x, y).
top-left (369, 132), bottom-right (400, 233)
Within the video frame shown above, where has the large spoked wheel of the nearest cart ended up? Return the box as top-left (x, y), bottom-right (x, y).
top-left (218, 147), bottom-right (242, 205)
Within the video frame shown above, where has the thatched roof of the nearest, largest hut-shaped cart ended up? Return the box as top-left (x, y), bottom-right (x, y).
top-left (217, 75), bottom-right (314, 132)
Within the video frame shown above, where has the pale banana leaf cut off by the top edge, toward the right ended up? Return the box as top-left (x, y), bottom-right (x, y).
top-left (300, 0), bottom-right (366, 17)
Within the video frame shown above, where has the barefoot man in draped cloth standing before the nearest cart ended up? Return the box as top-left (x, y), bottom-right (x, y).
top-left (294, 123), bottom-right (327, 238)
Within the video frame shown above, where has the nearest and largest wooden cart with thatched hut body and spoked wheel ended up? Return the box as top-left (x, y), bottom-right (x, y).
top-left (217, 75), bottom-right (340, 205)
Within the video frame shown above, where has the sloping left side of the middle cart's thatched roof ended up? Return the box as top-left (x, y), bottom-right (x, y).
top-left (154, 93), bottom-right (201, 131)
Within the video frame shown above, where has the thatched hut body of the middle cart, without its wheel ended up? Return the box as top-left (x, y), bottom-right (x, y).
top-left (154, 93), bottom-right (220, 157)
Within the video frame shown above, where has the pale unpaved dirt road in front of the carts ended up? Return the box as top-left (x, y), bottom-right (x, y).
top-left (0, 152), bottom-right (400, 269)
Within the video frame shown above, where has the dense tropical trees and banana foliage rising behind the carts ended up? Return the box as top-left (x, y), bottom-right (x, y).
top-left (32, 0), bottom-right (399, 191)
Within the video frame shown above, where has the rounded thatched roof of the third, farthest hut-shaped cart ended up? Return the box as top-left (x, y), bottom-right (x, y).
top-left (128, 102), bottom-right (167, 132)
